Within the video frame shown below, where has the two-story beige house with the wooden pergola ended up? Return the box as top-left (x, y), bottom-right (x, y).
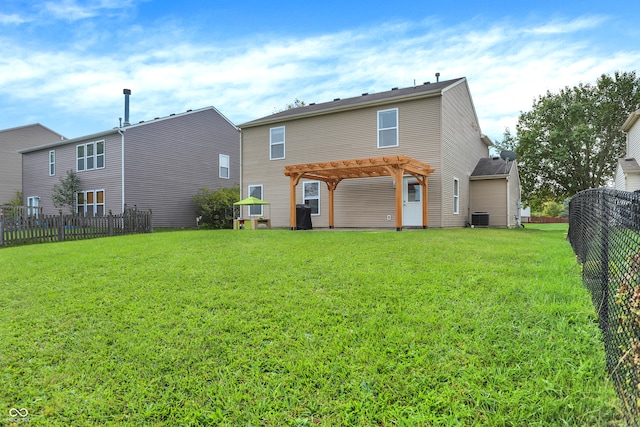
top-left (239, 78), bottom-right (491, 229)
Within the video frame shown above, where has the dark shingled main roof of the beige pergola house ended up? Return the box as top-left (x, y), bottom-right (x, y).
top-left (238, 77), bottom-right (466, 128)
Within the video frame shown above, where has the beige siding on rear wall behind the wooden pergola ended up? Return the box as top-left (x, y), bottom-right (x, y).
top-left (242, 97), bottom-right (440, 227)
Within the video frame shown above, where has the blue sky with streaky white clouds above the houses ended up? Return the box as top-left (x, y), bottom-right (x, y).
top-left (0, 0), bottom-right (640, 139)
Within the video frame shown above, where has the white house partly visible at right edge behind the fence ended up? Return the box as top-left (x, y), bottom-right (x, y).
top-left (614, 110), bottom-right (640, 191)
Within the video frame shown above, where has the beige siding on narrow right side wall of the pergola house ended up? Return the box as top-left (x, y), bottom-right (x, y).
top-left (440, 80), bottom-right (489, 227)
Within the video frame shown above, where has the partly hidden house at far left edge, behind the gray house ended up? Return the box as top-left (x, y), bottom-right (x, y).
top-left (0, 123), bottom-right (64, 205)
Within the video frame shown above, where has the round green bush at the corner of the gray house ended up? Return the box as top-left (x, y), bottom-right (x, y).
top-left (193, 186), bottom-right (240, 229)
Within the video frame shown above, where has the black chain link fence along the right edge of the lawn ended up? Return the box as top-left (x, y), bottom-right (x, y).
top-left (569, 189), bottom-right (640, 427)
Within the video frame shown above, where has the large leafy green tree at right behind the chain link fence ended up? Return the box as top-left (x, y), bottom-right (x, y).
top-left (515, 72), bottom-right (640, 209)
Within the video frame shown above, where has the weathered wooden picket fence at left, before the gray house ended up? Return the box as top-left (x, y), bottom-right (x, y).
top-left (0, 207), bottom-right (153, 246)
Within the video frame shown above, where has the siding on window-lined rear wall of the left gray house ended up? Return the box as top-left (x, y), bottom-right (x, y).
top-left (22, 133), bottom-right (122, 214)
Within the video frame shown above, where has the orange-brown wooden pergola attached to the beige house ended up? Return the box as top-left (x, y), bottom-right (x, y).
top-left (284, 155), bottom-right (435, 231)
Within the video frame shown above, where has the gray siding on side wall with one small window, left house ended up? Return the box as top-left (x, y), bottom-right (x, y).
top-left (125, 109), bottom-right (239, 227)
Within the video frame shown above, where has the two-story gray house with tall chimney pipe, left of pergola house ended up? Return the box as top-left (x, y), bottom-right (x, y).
top-left (21, 105), bottom-right (240, 227)
